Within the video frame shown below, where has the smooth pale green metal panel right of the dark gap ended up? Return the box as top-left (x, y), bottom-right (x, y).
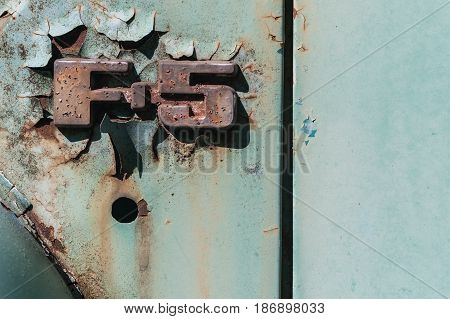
top-left (294, 0), bottom-right (450, 298)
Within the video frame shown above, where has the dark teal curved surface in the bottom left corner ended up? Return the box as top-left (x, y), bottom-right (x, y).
top-left (0, 207), bottom-right (72, 298)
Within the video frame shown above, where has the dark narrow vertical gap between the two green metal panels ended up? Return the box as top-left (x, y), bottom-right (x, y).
top-left (280, 0), bottom-right (294, 299)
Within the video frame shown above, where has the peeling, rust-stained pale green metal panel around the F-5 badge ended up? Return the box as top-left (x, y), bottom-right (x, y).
top-left (0, 0), bottom-right (282, 298)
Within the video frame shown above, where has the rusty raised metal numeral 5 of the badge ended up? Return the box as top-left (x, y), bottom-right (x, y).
top-left (152, 61), bottom-right (237, 128)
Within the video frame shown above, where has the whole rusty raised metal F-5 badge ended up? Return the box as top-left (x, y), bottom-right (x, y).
top-left (53, 58), bottom-right (237, 128)
